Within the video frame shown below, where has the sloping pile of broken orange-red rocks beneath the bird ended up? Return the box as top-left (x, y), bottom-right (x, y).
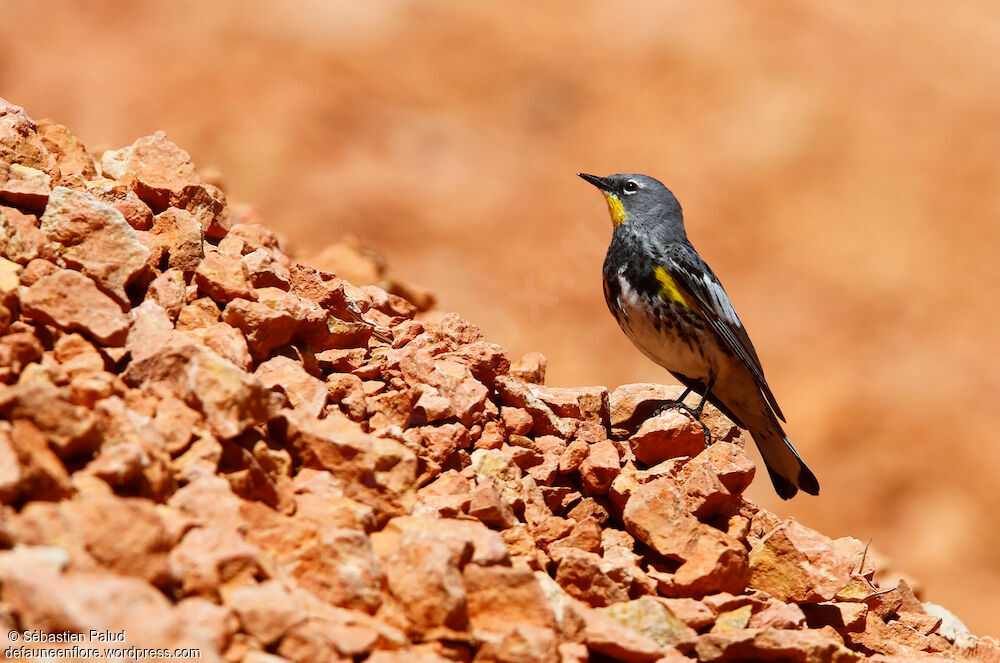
top-left (0, 100), bottom-right (997, 663)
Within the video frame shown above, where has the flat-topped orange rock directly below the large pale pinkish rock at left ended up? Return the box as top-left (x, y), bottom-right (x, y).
top-left (21, 269), bottom-right (128, 346)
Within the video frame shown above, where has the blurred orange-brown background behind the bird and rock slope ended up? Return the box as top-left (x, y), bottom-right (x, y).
top-left (0, 0), bottom-right (1000, 635)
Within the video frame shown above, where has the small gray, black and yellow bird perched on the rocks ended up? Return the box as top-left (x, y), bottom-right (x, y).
top-left (578, 173), bottom-right (819, 500)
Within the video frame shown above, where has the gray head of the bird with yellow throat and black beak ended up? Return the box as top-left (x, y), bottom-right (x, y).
top-left (577, 173), bottom-right (684, 235)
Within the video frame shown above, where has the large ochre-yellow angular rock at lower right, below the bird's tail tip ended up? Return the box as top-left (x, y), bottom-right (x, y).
top-left (749, 520), bottom-right (856, 602)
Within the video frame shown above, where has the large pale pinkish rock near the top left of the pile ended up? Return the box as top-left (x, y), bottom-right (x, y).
top-left (39, 187), bottom-right (149, 305)
